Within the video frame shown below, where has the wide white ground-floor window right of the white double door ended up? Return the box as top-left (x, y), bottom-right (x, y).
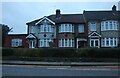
top-left (101, 38), bottom-right (118, 47)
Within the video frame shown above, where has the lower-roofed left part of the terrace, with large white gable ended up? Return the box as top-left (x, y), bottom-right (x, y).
top-left (27, 9), bottom-right (87, 48)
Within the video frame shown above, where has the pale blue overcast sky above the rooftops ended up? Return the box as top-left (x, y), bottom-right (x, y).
top-left (0, 1), bottom-right (118, 34)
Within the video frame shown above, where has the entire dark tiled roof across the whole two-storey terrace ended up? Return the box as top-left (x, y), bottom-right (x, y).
top-left (27, 11), bottom-right (120, 24)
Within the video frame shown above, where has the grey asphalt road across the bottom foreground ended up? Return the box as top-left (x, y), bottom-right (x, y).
top-left (2, 65), bottom-right (120, 76)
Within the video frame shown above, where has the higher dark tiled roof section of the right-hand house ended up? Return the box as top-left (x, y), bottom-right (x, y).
top-left (83, 11), bottom-right (120, 20)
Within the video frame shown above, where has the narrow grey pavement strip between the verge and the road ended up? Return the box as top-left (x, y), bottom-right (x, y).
top-left (2, 61), bottom-right (120, 66)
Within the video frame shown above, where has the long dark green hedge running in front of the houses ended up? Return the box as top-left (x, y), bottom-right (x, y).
top-left (2, 48), bottom-right (120, 58)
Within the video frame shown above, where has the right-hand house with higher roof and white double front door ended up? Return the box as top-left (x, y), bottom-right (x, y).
top-left (83, 5), bottom-right (120, 48)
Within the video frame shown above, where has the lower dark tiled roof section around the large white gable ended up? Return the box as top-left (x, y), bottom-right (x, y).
top-left (27, 14), bottom-right (85, 24)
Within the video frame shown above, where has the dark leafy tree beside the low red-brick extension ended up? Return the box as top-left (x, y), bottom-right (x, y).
top-left (0, 24), bottom-right (12, 47)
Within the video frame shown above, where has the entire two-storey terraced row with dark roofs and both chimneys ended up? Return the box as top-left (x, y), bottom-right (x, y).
top-left (4, 5), bottom-right (120, 48)
